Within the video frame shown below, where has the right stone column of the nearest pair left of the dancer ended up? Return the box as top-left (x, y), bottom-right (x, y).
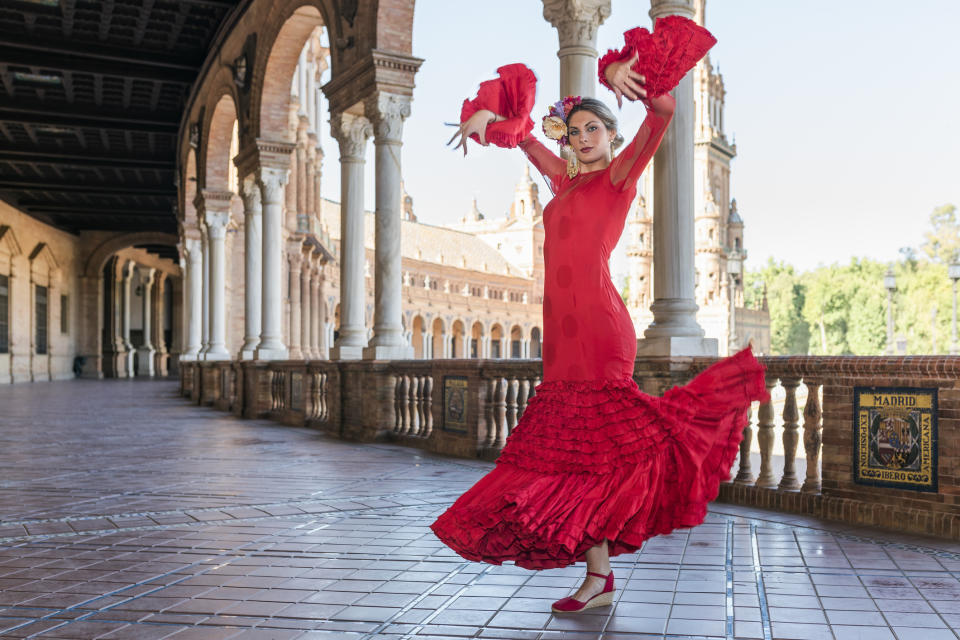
top-left (363, 93), bottom-right (413, 360)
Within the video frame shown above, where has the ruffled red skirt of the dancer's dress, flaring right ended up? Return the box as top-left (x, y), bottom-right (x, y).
top-left (431, 350), bottom-right (767, 569)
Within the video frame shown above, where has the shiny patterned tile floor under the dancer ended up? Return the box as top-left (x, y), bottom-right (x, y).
top-left (0, 381), bottom-right (960, 640)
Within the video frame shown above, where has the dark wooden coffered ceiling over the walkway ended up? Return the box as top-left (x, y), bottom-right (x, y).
top-left (0, 0), bottom-right (240, 233)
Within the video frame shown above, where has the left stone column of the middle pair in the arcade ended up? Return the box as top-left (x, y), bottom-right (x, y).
top-left (240, 176), bottom-right (263, 360)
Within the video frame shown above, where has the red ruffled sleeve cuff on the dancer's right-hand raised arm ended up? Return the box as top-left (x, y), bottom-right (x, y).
top-left (598, 16), bottom-right (717, 99)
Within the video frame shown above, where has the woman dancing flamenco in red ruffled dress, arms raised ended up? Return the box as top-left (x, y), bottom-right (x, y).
top-left (431, 16), bottom-right (767, 613)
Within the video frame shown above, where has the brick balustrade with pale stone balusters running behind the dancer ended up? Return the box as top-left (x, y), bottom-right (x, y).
top-left (181, 356), bottom-right (960, 537)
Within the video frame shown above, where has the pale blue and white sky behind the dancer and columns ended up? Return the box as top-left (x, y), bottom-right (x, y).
top-left (322, 0), bottom-right (960, 274)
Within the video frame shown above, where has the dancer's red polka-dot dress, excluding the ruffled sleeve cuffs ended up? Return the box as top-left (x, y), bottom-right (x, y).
top-left (432, 51), bottom-right (766, 569)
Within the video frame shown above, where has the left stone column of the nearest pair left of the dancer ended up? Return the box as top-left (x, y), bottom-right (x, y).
top-left (330, 113), bottom-right (374, 360)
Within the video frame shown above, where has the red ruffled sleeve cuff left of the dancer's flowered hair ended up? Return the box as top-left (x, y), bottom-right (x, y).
top-left (460, 63), bottom-right (537, 149)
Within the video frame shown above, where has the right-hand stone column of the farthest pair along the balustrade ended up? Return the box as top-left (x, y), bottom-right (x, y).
top-left (198, 189), bottom-right (233, 360)
